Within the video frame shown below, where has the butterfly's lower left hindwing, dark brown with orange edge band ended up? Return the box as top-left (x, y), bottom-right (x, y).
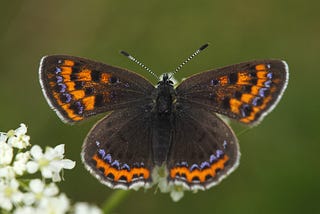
top-left (82, 108), bottom-right (153, 189)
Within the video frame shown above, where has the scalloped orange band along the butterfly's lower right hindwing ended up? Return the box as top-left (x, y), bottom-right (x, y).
top-left (170, 155), bottom-right (229, 183)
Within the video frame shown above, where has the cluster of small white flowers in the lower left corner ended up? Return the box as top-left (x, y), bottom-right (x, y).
top-left (0, 124), bottom-right (102, 214)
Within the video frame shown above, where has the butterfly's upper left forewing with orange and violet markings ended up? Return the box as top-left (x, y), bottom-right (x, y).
top-left (39, 55), bottom-right (154, 123)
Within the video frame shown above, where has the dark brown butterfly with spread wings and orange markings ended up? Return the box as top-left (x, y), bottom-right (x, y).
top-left (39, 44), bottom-right (288, 190)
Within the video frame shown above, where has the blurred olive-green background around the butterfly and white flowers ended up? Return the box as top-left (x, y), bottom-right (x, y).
top-left (0, 0), bottom-right (320, 214)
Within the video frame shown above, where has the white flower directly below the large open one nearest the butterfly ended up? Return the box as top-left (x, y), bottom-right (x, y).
top-left (23, 179), bottom-right (59, 205)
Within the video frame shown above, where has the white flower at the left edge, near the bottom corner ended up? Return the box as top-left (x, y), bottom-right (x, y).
top-left (0, 179), bottom-right (23, 211)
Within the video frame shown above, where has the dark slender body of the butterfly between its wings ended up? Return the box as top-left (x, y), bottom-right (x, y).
top-left (152, 74), bottom-right (175, 165)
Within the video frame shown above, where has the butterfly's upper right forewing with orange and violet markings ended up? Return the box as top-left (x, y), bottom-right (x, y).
top-left (176, 60), bottom-right (288, 125)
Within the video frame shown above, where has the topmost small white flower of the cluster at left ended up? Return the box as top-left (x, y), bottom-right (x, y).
top-left (7, 123), bottom-right (30, 149)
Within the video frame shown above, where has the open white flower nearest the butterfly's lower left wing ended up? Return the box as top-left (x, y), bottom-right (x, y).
top-left (27, 144), bottom-right (75, 182)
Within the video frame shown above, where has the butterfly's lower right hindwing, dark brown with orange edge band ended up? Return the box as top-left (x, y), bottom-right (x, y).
top-left (167, 106), bottom-right (240, 190)
